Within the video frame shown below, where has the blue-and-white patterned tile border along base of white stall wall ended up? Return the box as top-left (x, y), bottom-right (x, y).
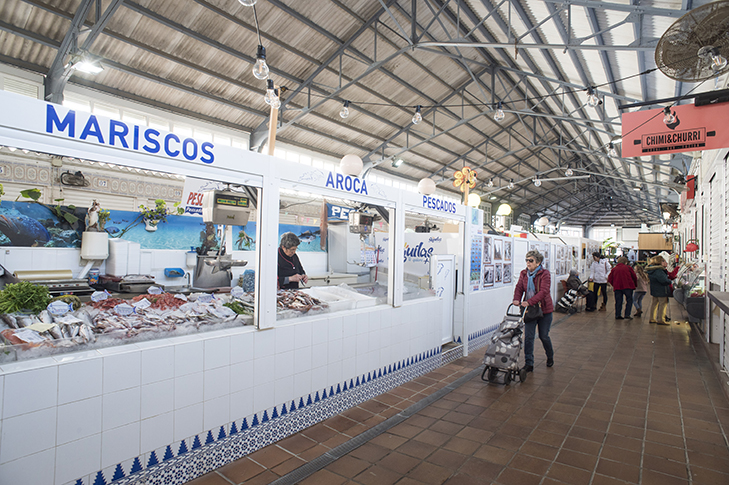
top-left (100, 346), bottom-right (444, 485)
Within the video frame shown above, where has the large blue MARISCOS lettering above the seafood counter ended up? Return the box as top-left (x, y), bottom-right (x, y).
top-left (46, 104), bottom-right (215, 164)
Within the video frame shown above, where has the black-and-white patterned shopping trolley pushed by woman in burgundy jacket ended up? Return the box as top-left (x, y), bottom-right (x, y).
top-left (481, 305), bottom-right (527, 384)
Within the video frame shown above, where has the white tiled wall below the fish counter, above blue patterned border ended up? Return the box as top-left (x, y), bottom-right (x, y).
top-left (0, 299), bottom-right (441, 485)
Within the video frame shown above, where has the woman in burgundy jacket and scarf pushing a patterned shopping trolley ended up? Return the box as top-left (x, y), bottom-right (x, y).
top-left (513, 251), bottom-right (554, 372)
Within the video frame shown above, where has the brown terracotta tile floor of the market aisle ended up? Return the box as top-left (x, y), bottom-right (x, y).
top-left (190, 298), bottom-right (729, 485)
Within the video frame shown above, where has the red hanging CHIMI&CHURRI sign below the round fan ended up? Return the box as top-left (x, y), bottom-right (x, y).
top-left (622, 103), bottom-right (729, 157)
